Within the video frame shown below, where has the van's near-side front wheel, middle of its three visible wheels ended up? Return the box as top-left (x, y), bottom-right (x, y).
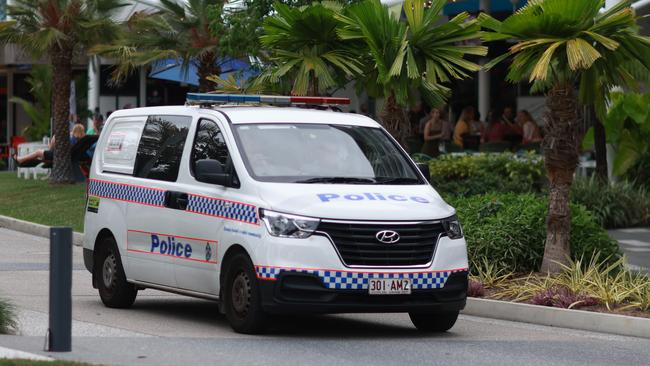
top-left (222, 253), bottom-right (266, 334)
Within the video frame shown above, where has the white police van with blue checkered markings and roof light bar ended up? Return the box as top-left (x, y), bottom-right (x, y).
top-left (84, 94), bottom-right (468, 333)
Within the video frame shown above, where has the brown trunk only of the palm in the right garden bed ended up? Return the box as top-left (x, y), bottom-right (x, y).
top-left (541, 84), bottom-right (583, 273)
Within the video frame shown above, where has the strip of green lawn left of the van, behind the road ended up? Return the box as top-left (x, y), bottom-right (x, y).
top-left (0, 172), bottom-right (86, 232)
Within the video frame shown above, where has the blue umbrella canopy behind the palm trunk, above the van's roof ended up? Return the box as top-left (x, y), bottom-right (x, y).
top-left (149, 58), bottom-right (257, 86)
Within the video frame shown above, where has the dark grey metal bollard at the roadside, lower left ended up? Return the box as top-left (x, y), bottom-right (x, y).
top-left (47, 227), bottom-right (72, 352)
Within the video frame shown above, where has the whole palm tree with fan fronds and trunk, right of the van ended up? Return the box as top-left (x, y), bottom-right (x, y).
top-left (479, 0), bottom-right (650, 272)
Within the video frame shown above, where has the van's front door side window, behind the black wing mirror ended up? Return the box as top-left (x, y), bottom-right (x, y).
top-left (190, 119), bottom-right (229, 174)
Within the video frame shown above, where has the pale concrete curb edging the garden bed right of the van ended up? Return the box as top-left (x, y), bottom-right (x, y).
top-left (462, 298), bottom-right (650, 338)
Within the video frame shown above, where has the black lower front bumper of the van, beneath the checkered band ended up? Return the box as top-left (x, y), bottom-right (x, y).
top-left (258, 270), bottom-right (467, 314)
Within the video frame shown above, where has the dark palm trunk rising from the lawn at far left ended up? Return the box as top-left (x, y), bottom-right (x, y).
top-left (50, 43), bottom-right (74, 184)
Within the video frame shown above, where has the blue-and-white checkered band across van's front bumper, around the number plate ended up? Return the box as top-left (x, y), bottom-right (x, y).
top-left (255, 266), bottom-right (455, 290)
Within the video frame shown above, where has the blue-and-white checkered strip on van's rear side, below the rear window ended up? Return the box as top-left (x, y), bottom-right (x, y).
top-left (88, 179), bottom-right (165, 207)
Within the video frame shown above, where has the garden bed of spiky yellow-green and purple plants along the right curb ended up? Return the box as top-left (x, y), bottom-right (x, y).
top-left (469, 255), bottom-right (650, 318)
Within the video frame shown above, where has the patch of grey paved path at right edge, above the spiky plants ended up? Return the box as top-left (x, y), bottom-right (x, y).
top-left (609, 228), bottom-right (650, 272)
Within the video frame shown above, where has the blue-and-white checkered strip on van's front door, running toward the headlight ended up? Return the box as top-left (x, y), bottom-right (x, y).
top-left (187, 195), bottom-right (259, 224)
